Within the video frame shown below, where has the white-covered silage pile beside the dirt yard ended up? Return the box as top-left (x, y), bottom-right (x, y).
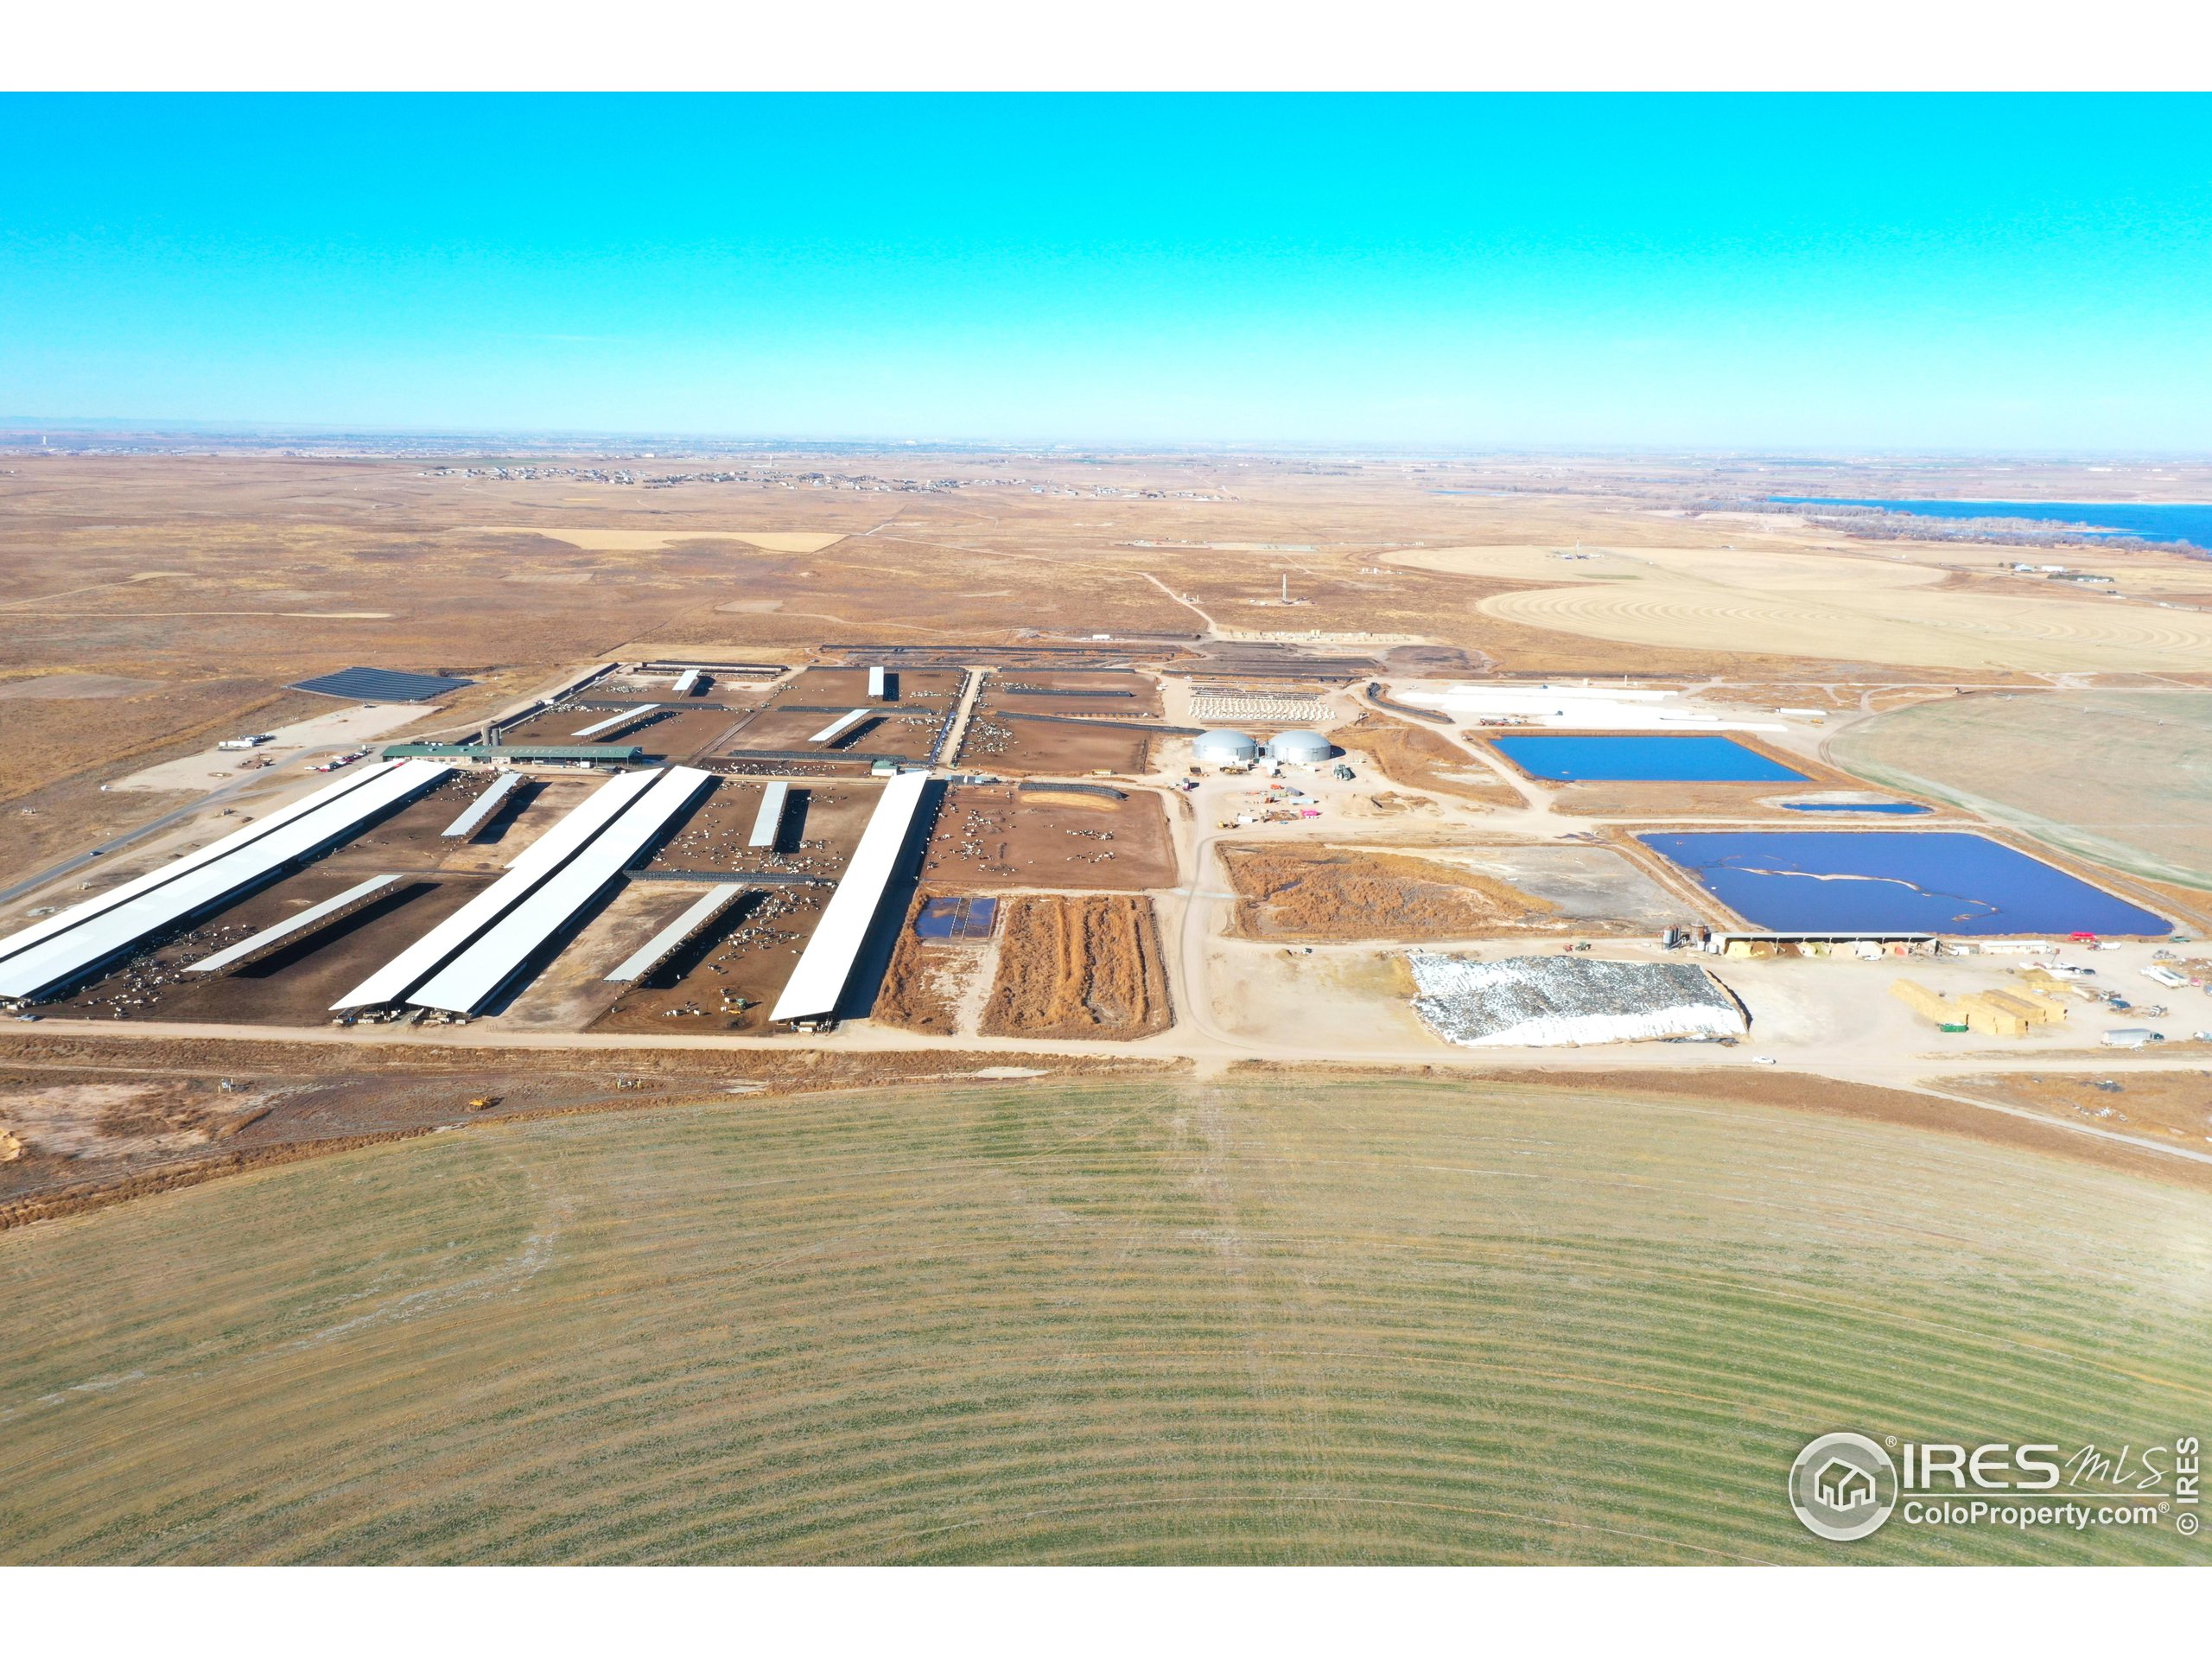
top-left (1407, 951), bottom-right (1750, 1048)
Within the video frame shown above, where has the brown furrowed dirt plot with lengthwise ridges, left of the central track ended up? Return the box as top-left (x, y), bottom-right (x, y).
top-left (982, 896), bottom-right (1173, 1038)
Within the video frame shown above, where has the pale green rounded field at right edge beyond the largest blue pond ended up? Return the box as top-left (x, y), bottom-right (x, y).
top-left (1832, 690), bottom-right (2212, 889)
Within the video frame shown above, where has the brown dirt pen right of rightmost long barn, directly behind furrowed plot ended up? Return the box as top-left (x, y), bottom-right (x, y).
top-left (923, 783), bottom-right (1177, 892)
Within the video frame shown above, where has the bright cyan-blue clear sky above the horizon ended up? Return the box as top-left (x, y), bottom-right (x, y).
top-left (0, 95), bottom-right (2212, 449)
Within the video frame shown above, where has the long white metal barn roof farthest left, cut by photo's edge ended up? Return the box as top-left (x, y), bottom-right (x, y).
top-left (0, 761), bottom-right (451, 998)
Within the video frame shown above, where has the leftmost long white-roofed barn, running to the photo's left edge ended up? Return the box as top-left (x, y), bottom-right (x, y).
top-left (0, 761), bottom-right (454, 998)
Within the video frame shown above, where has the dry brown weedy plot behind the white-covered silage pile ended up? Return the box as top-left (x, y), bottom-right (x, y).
top-left (1221, 842), bottom-right (1564, 940)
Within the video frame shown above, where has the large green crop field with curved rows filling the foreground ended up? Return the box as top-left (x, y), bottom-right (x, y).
top-left (0, 1084), bottom-right (2212, 1561)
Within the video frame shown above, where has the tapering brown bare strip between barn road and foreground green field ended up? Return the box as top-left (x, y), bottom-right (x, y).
top-left (0, 1035), bottom-right (1188, 1230)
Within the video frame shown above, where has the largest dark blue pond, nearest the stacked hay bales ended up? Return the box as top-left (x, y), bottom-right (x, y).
top-left (1637, 830), bottom-right (2172, 936)
